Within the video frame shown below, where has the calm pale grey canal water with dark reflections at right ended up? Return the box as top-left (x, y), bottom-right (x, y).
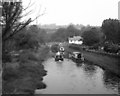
top-left (35, 58), bottom-right (120, 94)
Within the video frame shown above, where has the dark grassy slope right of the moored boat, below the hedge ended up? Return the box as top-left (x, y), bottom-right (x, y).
top-left (82, 51), bottom-right (120, 76)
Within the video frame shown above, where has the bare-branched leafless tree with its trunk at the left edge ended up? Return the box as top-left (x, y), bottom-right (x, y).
top-left (1, 2), bottom-right (41, 62)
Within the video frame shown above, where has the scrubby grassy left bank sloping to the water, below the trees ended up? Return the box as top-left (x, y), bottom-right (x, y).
top-left (3, 46), bottom-right (49, 94)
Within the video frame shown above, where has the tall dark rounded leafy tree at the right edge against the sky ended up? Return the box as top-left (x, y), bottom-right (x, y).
top-left (102, 19), bottom-right (120, 43)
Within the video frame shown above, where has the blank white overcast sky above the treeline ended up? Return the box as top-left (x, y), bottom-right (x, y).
top-left (23, 0), bottom-right (120, 26)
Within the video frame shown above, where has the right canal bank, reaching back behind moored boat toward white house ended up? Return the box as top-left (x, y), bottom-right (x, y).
top-left (67, 46), bottom-right (120, 77)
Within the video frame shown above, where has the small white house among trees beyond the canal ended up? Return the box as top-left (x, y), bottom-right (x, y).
top-left (68, 36), bottom-right (83, 45)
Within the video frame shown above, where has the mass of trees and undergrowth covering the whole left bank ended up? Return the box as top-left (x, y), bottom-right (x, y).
top-left (0, 2), bottom-right (49, 94)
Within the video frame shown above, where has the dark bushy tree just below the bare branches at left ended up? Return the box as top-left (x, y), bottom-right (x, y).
top-left (13, 28), bottom-right (38, 50)
